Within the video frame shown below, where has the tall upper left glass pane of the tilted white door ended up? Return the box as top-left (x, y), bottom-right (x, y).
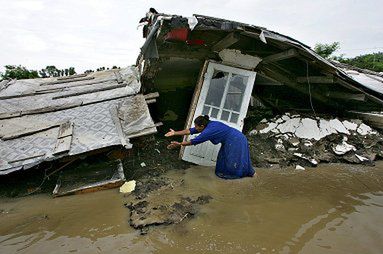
top-left (205, 70), bottom-right (229, 107)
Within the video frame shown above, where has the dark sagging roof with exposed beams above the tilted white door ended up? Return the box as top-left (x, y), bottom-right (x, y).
top-left (139, 14), bottom-right (383, 111)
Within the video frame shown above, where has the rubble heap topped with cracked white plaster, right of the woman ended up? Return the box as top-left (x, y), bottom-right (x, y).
top-left (248, 113), bottom-right (383, 169)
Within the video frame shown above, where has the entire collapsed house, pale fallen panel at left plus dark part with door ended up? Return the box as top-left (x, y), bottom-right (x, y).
top-left (0, 14), bottom-right (383, 185)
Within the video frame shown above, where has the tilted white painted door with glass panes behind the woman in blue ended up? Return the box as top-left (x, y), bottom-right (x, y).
top-left (182, 63), bottom-right (256, 166)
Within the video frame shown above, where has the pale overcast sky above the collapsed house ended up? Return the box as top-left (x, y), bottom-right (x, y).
top-left (0, 0), bottom-right (383, 73)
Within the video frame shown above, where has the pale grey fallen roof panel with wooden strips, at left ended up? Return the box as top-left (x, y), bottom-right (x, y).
top-left (0, 67), bottom-right (157, 175)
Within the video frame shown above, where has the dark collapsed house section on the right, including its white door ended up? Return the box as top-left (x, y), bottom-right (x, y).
top-left (137, 14), bottom-right (383, 165)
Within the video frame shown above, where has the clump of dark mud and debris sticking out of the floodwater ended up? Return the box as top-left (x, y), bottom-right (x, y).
top-left (125, 176), bottom-right (211, 234)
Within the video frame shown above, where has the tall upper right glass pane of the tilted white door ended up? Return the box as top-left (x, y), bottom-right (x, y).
top-left (224, 74), bottom-right (248, 112)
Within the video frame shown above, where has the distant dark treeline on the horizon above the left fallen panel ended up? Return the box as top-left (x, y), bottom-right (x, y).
top-left (0, 65), bottom-right (119, 80)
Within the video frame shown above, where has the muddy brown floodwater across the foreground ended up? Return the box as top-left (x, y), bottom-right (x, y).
top-left (0, 162), bottom-right (383, 254)
